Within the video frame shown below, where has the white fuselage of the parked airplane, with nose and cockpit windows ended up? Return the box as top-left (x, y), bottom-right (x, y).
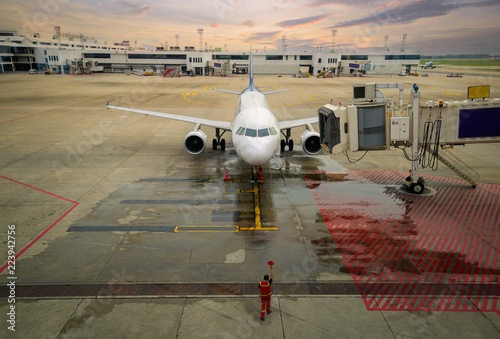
top-left (232, 85), bottom-right (280, 166)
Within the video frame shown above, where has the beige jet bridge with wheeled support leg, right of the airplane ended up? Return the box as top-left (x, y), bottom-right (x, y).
top-left (318, 84), bottom-right (500, 194)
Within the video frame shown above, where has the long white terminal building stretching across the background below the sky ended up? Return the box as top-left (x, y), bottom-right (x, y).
top-left (0, 31), bottom-right (420, 76)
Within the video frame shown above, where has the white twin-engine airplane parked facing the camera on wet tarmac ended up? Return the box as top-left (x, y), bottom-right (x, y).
top-left (106, 52), bottom-right (322, 173)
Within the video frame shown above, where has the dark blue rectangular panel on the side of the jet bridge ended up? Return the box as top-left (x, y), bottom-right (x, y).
top-left (458, 107), bottom-right (500, 138)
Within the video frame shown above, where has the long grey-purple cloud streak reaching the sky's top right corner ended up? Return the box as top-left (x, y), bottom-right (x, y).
top-left (329, 0), bottom-right (500, 28)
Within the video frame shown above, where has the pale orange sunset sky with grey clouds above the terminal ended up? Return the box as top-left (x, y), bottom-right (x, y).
top-left (0, 0), bottom-right (500, 55)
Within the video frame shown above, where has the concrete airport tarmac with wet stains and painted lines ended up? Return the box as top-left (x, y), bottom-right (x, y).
top-left (0, 68), bottom-right (500, 338)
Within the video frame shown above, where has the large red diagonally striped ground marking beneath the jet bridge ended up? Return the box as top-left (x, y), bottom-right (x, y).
top-left (305, 171), bottom-right (500, 313)
